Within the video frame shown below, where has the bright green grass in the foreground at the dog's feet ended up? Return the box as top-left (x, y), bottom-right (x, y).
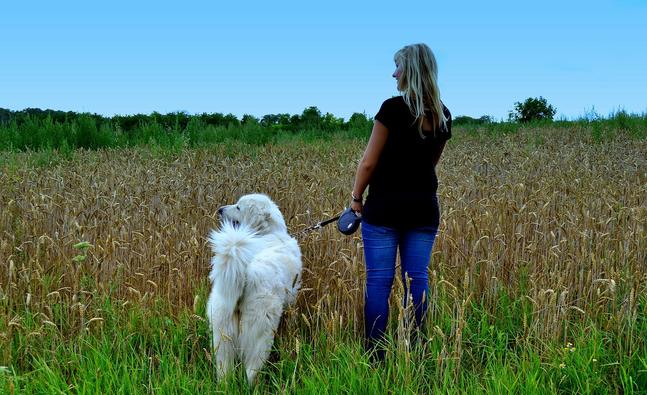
top-left (0, 287), bottom-right (647, 394)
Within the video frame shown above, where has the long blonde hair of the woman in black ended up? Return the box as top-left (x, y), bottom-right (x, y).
top-left (393, 44), bottom-right (446, 138)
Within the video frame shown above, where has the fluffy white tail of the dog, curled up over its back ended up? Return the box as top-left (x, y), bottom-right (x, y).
top-left (208, 222), bottom-right (258, 300)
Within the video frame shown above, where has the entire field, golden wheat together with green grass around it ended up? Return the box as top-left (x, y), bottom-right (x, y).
top-left (0, 113), bottom-right (647, 394)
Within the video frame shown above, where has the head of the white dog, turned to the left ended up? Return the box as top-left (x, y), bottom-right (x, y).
top-left (218, 193), bottom-right (287, 234)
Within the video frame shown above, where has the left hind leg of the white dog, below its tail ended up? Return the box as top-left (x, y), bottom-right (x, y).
top-left (207, 302), bottom-right (238, 379)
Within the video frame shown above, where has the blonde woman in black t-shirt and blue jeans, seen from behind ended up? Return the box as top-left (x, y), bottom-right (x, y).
top-left (351, 44), bottom-right (451, 359)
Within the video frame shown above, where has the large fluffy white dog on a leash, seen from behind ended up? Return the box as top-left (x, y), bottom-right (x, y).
top-left (207, 194), bottom-right (302, 383)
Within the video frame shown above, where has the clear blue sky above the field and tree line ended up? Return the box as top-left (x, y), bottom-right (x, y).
top-left (0, 0), bottom-right (647, 119)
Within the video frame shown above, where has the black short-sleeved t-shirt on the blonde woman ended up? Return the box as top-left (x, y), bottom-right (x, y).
top-left (362, 96), bottom-right (452, 228)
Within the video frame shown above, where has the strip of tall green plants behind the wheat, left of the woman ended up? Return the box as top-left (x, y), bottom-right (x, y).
top-left (0, 115), bottom-right (370, 152)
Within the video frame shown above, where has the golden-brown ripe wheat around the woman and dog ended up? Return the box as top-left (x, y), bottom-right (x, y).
top-left (0, 129), bottom-right (647, 364)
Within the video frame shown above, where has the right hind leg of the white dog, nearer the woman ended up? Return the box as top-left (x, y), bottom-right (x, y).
top-left (239, 293), bottom-right (283, 384)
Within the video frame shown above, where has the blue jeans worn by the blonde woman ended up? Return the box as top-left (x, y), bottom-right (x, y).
top-left (362, 222), bottom-right (438, 358)
